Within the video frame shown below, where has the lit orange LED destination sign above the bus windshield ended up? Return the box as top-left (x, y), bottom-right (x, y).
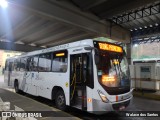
top-left (98, 43), bottom-right (123, 53)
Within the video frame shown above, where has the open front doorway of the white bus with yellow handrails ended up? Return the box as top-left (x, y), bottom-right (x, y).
top-left (70, 53), bottom-right (87, 110)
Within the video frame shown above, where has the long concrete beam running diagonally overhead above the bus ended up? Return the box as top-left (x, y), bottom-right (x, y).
top-left (8, 0), bottom-right (130, 43)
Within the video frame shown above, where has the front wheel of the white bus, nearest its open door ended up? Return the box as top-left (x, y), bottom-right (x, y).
top-left (55, 90), bottom-right (66, 110)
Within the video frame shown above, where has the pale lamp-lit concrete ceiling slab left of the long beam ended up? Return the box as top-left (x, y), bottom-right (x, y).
top-left (0, 1), bottom-right (97, 48)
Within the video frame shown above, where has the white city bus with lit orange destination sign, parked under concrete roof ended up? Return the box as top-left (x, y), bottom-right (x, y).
top-left (5, 39), bottom-right (132, 113)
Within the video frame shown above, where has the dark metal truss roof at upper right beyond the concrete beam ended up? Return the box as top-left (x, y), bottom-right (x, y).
top-left (69, 0), bottom-right (160, 42)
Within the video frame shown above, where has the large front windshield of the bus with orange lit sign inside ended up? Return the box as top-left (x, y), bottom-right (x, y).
top-left (97, 50), bottom-right (130, 91)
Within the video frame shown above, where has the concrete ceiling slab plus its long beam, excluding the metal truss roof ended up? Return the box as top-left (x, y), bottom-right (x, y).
top-left (0, 0), bottom-right (130, 51)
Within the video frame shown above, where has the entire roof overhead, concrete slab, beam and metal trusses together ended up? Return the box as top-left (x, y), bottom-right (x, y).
top-left (0, 0), bottom-right (160, 51)
